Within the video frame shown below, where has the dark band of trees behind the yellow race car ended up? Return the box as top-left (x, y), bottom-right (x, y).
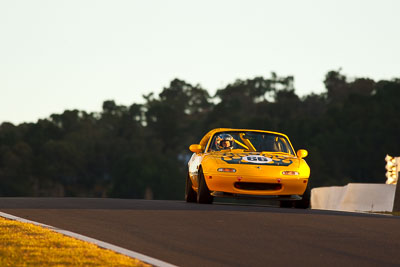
top-left (0, 70), bottom-right (400, 199)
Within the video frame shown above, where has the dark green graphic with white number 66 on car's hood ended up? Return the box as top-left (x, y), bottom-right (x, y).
top-left (221, 152), bottom-right (293, 166)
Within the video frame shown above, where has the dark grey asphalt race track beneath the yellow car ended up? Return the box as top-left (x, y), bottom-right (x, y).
top-left (0, 198), bottom-right (400, 266)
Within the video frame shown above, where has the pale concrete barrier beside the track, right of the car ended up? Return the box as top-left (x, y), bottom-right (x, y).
top-left (311, 183), bottom-right (396, 212)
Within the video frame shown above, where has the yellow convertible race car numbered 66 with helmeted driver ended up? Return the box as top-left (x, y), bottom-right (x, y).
top-left (185, 128), bottom-right (310, 208)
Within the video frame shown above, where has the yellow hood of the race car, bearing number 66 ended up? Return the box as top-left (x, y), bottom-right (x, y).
top-left (207, 151), bottom-right (299, 166)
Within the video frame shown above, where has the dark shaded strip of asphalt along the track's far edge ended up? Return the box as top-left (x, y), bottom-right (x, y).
top-left (0, 197), bottom-right (399, 219)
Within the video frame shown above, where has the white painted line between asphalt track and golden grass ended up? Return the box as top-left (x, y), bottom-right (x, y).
top-left (0, 212), bottom-right (177, 267)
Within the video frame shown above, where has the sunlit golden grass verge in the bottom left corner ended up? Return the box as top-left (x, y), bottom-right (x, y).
top-left (0, 217), bottom-right (150, 266)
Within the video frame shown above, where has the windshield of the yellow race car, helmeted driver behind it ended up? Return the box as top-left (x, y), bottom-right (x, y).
top-left (209, 131), bottom-right (294, 155)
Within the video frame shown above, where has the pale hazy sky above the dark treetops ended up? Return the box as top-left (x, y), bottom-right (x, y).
top-left (0, 0), bottom-right (400, 123)
